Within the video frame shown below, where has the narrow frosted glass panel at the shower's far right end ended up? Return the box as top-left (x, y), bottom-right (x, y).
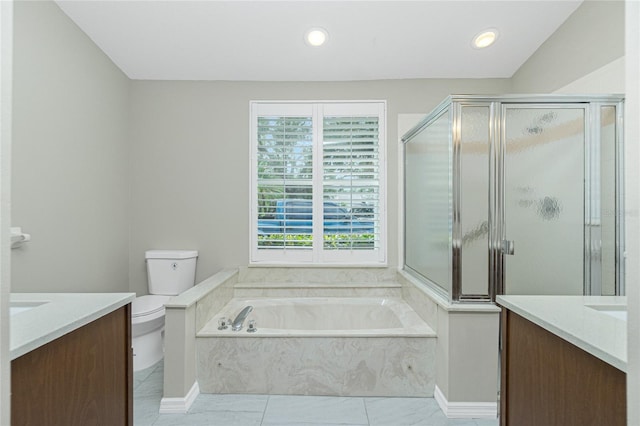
top-left (592, 106), bottom-right (616, 296)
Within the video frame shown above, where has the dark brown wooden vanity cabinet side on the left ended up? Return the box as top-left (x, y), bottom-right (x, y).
top-left (11, 304), bottom-right (133, 426)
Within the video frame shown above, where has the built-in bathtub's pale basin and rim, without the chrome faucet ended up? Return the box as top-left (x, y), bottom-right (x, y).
top-left (197, 297), bottom-right (436, 338)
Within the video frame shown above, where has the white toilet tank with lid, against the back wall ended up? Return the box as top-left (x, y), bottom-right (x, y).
top-left (145, 250), bottom-right (198, 296)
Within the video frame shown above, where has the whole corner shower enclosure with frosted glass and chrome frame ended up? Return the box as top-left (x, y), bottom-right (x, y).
top-left (402, 95), bottom-right (624, 302)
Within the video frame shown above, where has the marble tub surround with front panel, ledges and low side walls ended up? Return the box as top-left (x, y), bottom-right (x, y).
top-left (161, 267), bottom-right (500, 417)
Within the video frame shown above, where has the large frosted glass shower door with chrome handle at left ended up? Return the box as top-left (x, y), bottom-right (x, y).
top-left (504, 105), bottom-right (585, 295)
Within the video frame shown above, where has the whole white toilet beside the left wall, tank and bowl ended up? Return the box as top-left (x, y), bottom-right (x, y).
top-left (131, 250), bottom-right (198, 371)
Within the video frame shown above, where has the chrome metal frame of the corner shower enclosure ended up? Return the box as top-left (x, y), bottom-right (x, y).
top-left (402, 95), bottom-right (625, 302)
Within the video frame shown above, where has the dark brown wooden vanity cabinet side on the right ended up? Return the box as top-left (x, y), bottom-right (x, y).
top-left (500, 308), bottom-right (626, 426)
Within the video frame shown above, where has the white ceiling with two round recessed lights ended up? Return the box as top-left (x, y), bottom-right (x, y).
top-left (57, 0), bottom-right (582, 81)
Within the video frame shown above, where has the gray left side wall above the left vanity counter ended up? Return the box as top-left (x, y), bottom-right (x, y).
top-left (11, 1), bottom-right (130, 292)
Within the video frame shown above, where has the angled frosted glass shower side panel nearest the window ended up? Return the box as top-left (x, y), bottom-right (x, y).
top-left (405, 112), bottom-right (452, 293)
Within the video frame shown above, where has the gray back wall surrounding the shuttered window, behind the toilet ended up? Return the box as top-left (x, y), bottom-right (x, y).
top-left (129, 79), bottom-right (510, 294)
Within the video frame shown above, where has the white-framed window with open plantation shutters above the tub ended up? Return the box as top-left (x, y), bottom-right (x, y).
top-left (250, 101), bottom-right (386, 265)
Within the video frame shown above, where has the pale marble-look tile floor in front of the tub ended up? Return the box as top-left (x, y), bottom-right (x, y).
top-left (133, 362), bottom-right (498, 426)
